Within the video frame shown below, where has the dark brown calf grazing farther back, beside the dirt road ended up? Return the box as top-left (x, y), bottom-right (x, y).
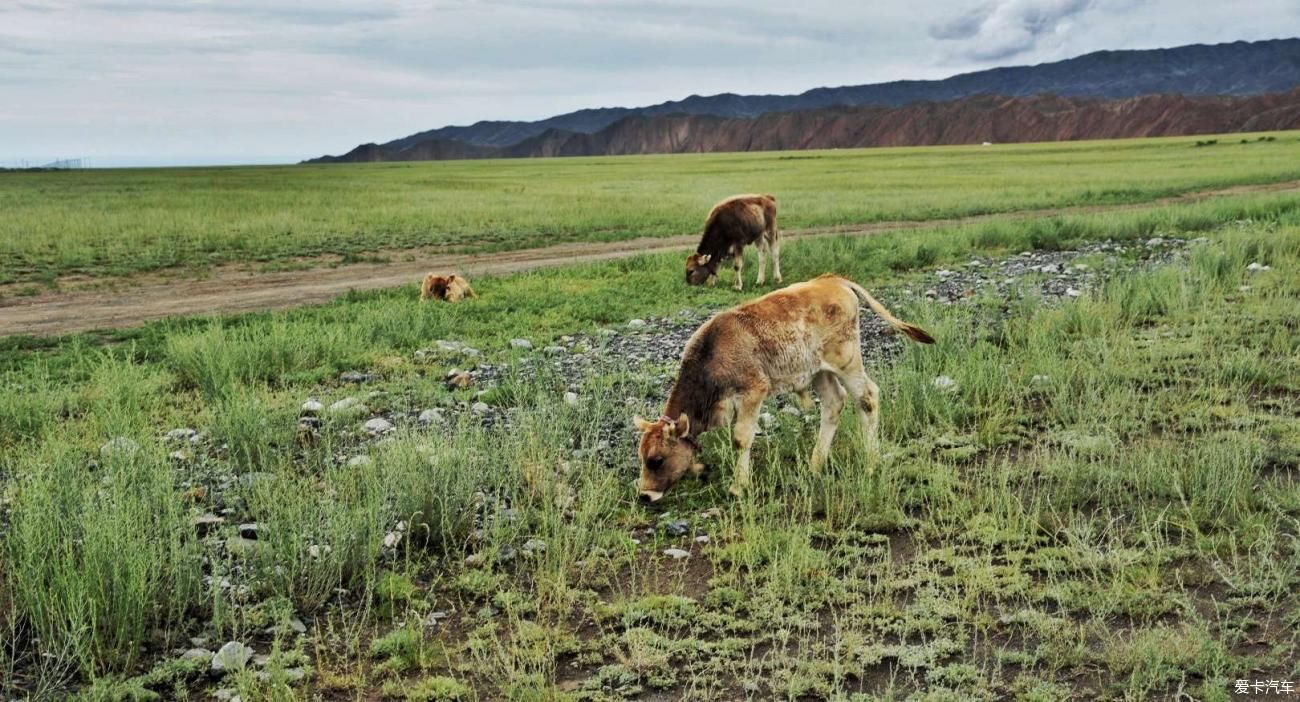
top-left (686, 195), bottom-right (781, 290)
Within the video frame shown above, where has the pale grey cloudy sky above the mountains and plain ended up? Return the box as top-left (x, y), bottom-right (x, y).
top-left (0, 0), bottom-right (1300, 165)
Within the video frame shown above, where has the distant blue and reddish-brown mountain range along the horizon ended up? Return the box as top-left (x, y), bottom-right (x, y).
top-left (308, 39), bottom-right (1300, 163)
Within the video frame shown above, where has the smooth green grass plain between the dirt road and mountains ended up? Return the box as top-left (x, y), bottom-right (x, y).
top-left (0, 133), bottom-right (1300, 284)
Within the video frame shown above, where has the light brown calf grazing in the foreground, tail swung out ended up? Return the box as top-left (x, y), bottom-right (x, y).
top-left (633, 273), bottom-right (935, 503)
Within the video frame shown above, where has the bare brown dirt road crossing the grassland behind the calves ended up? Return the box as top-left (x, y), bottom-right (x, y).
top-left (0, 181), bottom-right (1300, 337)
